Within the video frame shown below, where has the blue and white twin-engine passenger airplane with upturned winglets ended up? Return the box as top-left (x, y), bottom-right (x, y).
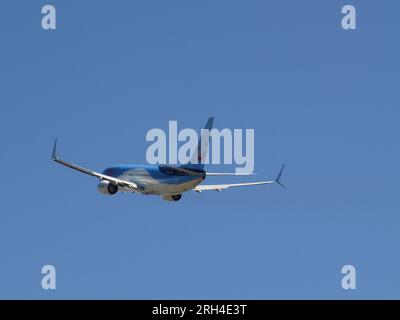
top-left (51, 117), bottom-right (285, 201)
